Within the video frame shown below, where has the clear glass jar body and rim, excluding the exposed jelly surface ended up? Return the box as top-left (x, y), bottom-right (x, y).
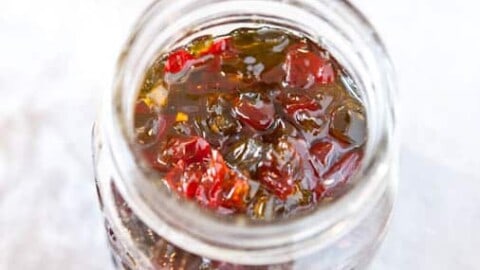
top-left (93, 0), bottom-right (397, 270)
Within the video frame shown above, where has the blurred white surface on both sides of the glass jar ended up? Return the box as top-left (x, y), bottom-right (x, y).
top-left (0, 0), bottom-right (480, 270)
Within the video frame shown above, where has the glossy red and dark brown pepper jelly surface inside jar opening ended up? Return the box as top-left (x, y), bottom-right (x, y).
top-left (135, 27), bottom-right (367, 220)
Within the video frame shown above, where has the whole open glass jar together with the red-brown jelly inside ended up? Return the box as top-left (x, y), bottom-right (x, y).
top-left (94, 0), bottom-right (395, 270)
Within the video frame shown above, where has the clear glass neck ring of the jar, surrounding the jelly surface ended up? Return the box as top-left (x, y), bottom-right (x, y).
top-left (104, 0), bottom-right (395, 264)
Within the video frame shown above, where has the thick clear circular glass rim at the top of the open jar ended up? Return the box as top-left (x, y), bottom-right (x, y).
top-left (104, 0), bottom-right (395, 264)
